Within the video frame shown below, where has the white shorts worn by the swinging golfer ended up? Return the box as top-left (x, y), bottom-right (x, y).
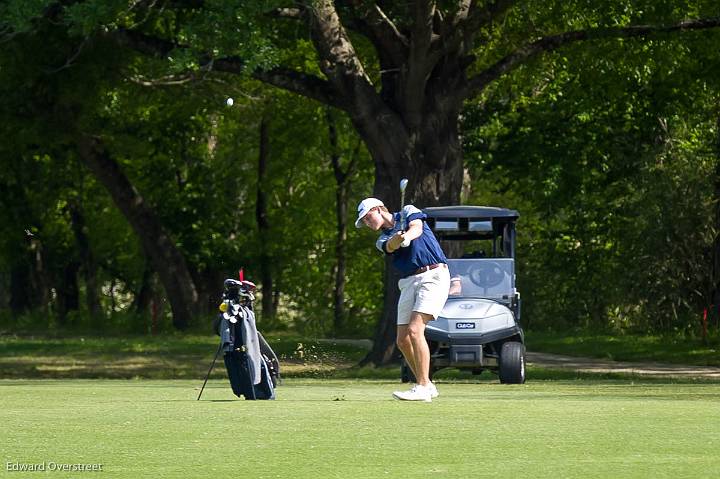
top-left (397, 265), bottom-right (450, 326)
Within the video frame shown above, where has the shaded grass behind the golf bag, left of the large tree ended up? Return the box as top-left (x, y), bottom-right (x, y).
top-left (0, 334), bottom-right (366, 379)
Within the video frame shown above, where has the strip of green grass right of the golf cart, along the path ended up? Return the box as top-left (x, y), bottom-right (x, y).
top-left (526, 331), bottom-right (720, 366)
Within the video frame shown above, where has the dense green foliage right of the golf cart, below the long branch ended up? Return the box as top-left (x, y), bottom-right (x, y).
top-left (465, 25), bottom-right (720, 332)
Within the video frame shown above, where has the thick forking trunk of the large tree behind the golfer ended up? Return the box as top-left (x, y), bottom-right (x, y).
top-left (308, 0), bottom-right (471, 364)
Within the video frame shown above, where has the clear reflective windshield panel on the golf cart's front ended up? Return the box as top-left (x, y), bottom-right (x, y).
top-left (448, 258), bottom-right (515, 300)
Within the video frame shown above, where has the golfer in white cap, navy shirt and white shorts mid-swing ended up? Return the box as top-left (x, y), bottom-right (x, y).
top-left (355, 198), bottom-right (450, 402)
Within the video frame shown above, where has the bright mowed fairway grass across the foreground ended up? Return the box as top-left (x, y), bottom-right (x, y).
top-left (0, 379), bottom-right (720, 479)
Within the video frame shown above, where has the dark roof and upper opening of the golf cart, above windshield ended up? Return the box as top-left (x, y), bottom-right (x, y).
top-left (423, 206), bottom-right (520, 243)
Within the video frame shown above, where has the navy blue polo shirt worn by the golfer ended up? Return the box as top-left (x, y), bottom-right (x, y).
top-left (375, 205), bottom-right (447, 276)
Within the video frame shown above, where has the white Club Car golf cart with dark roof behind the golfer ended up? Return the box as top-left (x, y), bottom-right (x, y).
top-left (401, 206), bottom-right (525, 384)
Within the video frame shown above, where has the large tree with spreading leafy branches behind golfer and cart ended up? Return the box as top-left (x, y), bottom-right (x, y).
top-left (2, 0), bottom-right (720, 352)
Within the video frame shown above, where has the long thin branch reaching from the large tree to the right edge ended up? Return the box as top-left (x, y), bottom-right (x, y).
top-left (466, 18), bottom-right (720, 98)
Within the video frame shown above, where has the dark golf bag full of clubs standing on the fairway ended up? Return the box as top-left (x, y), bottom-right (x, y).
top-left (215, 279), bottom-right (280, 399)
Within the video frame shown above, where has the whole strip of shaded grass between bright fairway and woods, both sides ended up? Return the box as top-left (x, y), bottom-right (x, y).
top-left (0, 333), bottom-right (720, 383)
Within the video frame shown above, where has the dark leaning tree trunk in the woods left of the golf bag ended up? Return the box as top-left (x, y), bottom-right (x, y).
top-left (78, 135), bottom-right (198, 330)
